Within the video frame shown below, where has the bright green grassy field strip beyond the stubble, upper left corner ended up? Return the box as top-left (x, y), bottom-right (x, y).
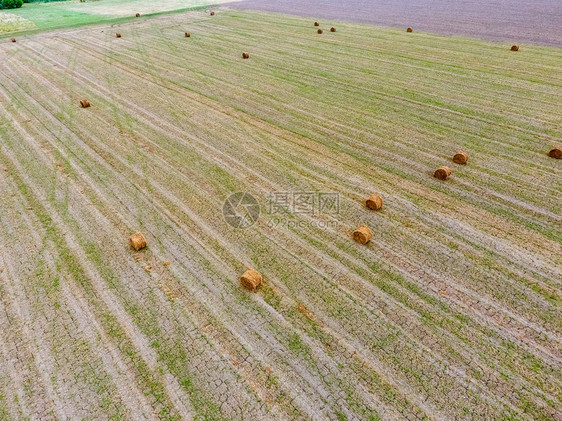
top-left (0, 0), bottom-right (232, 36)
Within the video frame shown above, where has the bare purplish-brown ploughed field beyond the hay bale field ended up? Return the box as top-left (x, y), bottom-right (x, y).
top-left (229, 0), bottom-right (562, 47)
